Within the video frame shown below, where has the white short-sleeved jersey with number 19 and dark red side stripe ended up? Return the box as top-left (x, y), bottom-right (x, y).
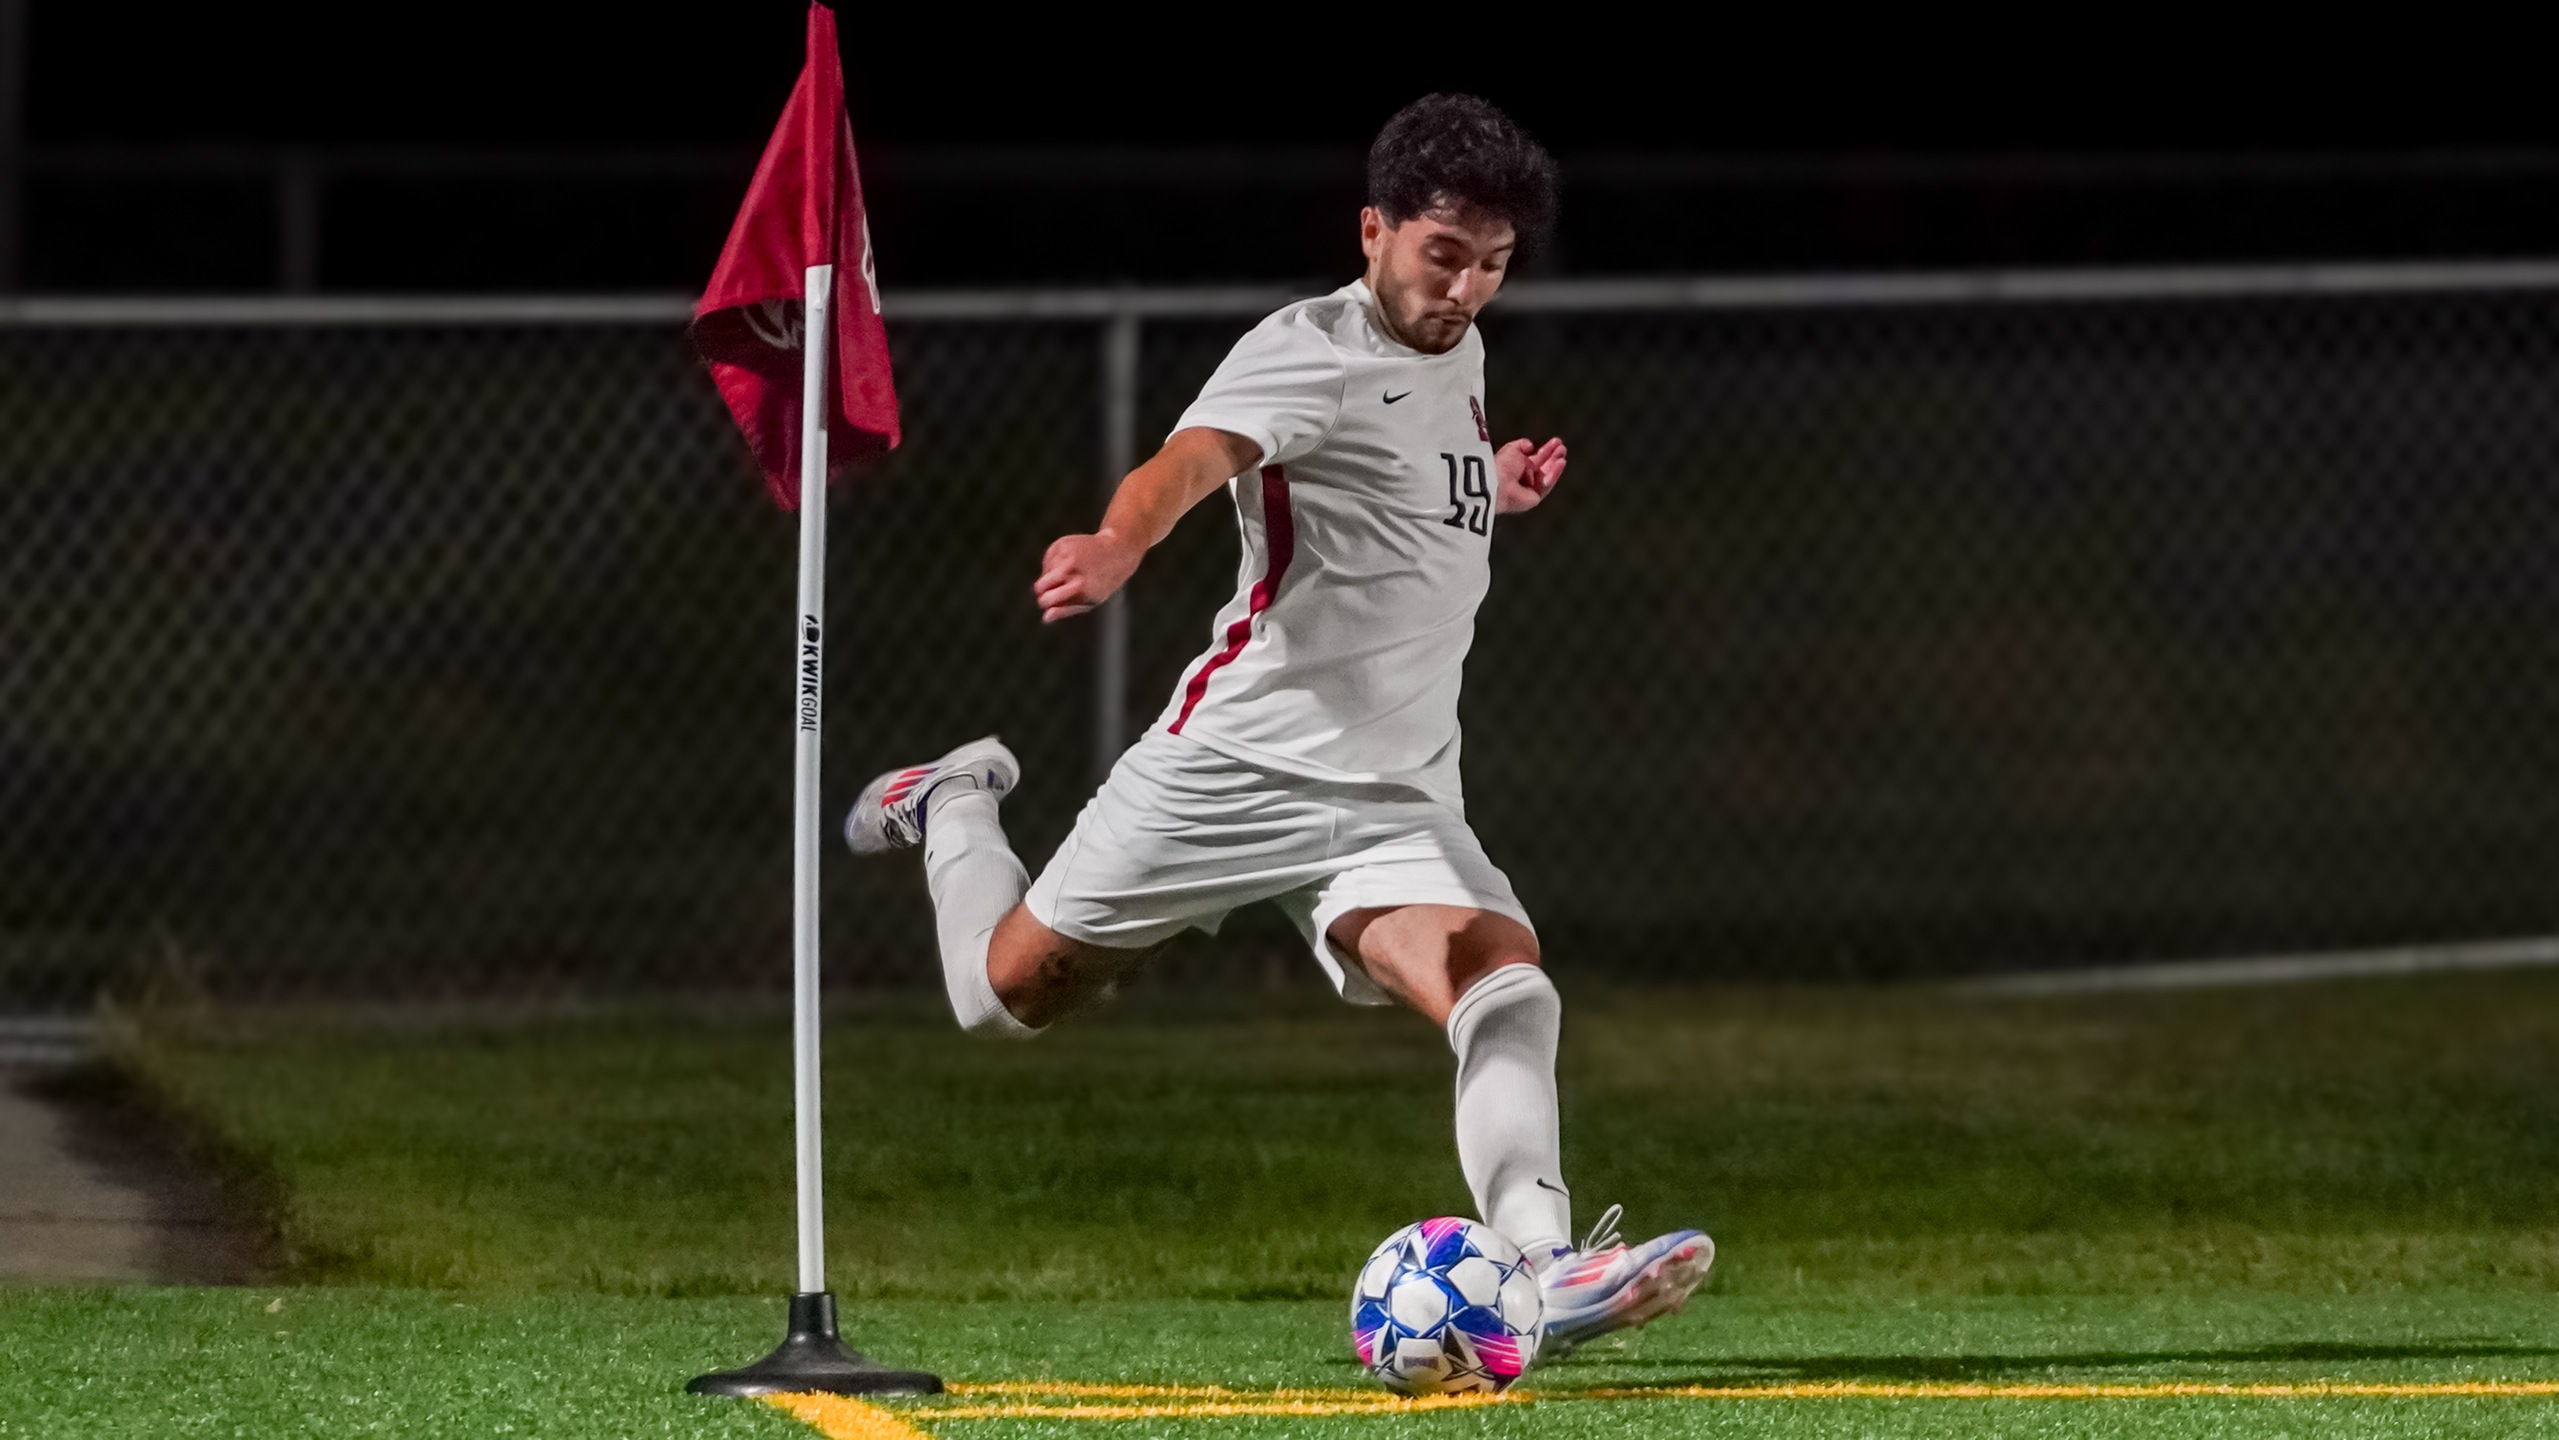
top-left (1157, 281), bottom-right (1494, 801)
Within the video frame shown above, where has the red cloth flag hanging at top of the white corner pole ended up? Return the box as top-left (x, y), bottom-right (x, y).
top-left (693, 5), bottom-right (898, 509)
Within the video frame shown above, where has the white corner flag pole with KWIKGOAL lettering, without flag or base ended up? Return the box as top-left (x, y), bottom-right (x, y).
top-left (791, 266), bottom-right (834, 1294)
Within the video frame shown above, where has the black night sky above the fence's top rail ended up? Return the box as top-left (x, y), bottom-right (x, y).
top-left (18, 0), bottom-right (2559, 292)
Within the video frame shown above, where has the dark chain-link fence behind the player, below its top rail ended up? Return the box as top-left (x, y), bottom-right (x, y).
top-left (0, 274), bottom-right (2559, 1008)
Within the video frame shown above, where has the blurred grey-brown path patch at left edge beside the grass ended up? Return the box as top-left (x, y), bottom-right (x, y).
top-left (0, 1072), bottom-right (261, 1284)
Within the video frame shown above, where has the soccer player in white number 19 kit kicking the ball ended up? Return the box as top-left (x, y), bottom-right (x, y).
top-left (844, 95), bottom-right (1715, 1353)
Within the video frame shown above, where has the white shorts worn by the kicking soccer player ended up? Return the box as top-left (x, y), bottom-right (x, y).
top-left (1024, 729), bottom-right (1535, 1005)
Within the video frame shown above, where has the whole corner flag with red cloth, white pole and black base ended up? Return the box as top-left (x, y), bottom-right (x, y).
top-left (686, 5), bottom-right (942, 1397)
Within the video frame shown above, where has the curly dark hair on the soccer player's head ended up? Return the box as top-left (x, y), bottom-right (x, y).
top-left (1369, 95), bottom-right (1556, 253)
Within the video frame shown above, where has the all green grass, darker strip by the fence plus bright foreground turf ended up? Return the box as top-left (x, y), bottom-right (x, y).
top-left (0, 974), bottom-right (2559, 1440)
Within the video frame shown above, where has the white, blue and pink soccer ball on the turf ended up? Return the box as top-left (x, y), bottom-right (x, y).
top-left (1351, 1215), bottom-right (1546, 1394)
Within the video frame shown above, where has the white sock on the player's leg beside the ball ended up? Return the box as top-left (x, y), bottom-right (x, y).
top-left (1448, 964), bottom-right (1574, 1261)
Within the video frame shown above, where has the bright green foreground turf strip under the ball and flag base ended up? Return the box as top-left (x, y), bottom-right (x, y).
top-left (15, 1289), bottom-right (2559, 1440)
